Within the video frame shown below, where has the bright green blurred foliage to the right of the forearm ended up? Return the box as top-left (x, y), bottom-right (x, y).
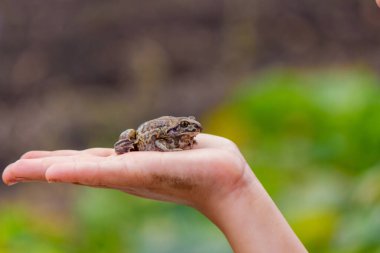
top-left (206, 66), bottom-right (380, 252)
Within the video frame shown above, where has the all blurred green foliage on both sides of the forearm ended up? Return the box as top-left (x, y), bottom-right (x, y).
top-left (0, 68), bottom-right (380, 253)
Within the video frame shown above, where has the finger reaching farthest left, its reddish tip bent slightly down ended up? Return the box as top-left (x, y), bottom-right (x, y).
top-left (2, 156), bottom-right (101, 185)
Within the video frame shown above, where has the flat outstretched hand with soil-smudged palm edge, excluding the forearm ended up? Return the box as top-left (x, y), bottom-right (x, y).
top-left (3, 134), bottom-right (252, 211)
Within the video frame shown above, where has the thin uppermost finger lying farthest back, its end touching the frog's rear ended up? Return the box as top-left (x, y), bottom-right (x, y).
top-left (21, 148), bottom-right (115, 159)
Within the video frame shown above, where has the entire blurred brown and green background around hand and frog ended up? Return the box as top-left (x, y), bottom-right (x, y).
top-left (0, 0), bottom-right (380, 253)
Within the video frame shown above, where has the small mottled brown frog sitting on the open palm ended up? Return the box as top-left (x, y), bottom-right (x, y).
top-left (114, 116), bottom-right (202, 155)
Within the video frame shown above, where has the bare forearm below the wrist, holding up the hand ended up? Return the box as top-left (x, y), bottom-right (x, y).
top-left (200, 166), bottom-right (306, 253)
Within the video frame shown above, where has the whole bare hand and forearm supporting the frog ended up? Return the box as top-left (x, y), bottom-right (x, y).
top-left (3, 134), bottom-right (306, 253)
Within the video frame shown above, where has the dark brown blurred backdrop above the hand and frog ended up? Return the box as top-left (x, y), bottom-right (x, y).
top-left (0, 0), bottom-right (380, 167)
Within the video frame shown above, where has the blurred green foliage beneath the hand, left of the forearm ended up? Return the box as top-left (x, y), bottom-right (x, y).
top-left (0, 188), bottom-right (231, 253)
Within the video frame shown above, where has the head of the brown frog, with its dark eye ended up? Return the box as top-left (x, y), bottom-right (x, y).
top-left (168, 116), bottom-right (202, 136)
